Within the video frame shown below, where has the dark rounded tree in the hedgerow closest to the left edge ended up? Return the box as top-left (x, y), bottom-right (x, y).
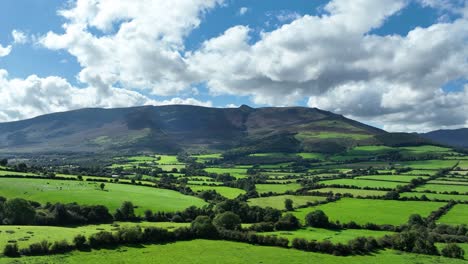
top-left (4, 198), bottom-right (36, 225)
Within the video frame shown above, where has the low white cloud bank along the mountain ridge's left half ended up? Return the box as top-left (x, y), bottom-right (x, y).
top-left (0, 69), bottom-right (212, 121)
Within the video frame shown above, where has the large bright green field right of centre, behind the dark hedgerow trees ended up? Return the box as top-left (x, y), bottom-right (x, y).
top-left (294, 198), bottom-right (446, 225)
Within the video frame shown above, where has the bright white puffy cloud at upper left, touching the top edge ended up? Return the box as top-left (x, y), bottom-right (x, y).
top-left (40, 0), bottom-right (222, 96)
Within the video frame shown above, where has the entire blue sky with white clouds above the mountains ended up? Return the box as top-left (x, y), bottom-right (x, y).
top-left (0, 0), bottom-right (468, 132)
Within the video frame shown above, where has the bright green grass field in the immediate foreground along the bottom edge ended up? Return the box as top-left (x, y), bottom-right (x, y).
top-left (0, 240), bottom-right (466, 264)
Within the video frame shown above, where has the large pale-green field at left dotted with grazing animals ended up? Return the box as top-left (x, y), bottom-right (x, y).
top-left (0, 178), bottom-right (205, 213)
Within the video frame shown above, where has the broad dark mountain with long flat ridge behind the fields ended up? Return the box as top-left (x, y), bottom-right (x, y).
top-left (0, 105), bottom-right (424, 153)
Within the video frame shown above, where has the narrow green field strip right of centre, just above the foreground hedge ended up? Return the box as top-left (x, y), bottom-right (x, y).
top-left (261, 227), bottom-right (393, 243)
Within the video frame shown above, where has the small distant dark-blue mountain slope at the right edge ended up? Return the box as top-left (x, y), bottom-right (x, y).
top-left (420, 128), bottom-right (468, 148)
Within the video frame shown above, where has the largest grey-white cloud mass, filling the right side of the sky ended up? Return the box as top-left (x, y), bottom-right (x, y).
top-left (188, 0), bottom-right (468, 130)
